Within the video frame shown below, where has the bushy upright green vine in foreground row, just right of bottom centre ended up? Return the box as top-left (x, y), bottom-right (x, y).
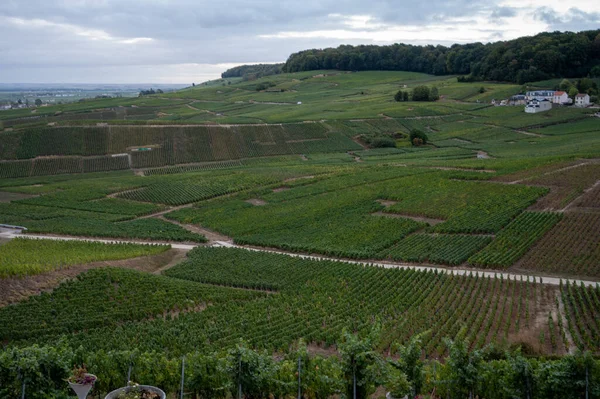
top-left (338, 326), bottom-right (390, 399)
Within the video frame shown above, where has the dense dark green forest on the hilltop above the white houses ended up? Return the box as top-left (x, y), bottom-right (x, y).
top-left (283, 30), bottom-right (600, 84)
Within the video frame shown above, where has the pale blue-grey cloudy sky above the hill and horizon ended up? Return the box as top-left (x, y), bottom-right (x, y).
top-left (0, 0), bottom-right (600, 84)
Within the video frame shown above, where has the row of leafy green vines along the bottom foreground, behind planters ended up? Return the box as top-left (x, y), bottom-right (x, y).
top-left (0, 333), bottom-right (600, 399)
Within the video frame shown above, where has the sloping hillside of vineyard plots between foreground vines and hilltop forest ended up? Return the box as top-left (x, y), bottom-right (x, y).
top-left (0, 71), bottom-right (600, 398)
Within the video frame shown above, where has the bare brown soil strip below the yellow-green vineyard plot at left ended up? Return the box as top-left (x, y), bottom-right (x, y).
top-left (0, 249), bottom-right (182, 307)
